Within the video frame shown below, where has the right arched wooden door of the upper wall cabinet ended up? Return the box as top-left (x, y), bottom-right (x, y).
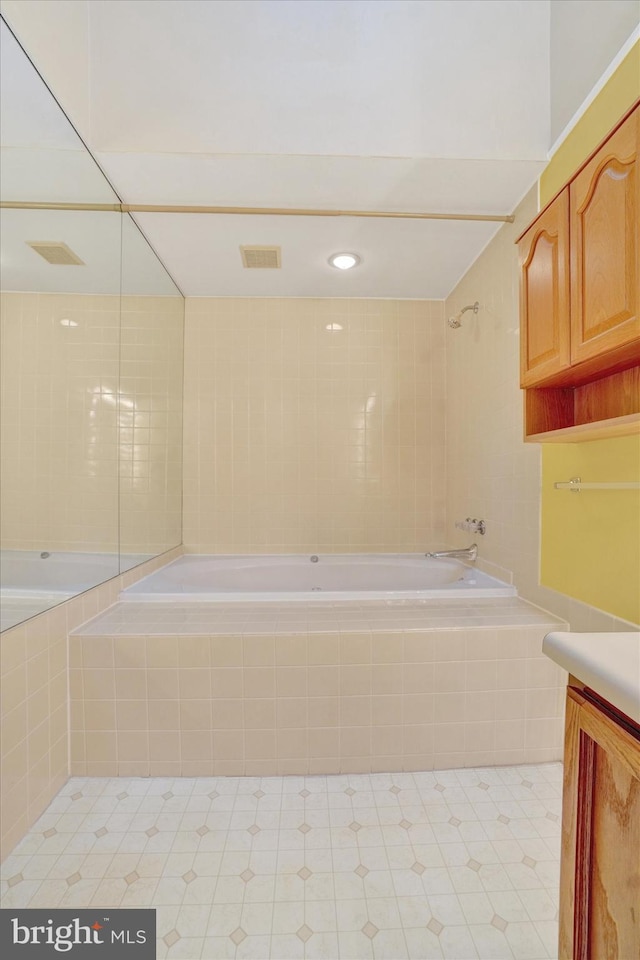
top-left (570, 108), bottom-right (640, 363)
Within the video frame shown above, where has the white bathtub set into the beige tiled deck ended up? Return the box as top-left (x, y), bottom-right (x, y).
top-left (120, 554), bottom-right (516, 603)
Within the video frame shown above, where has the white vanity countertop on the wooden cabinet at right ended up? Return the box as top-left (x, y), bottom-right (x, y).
top-left (542, 631), bottom-right (640, 723)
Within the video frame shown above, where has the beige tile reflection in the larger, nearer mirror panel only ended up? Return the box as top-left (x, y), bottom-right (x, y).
top-left (1, 292), bottom-right (120, 553)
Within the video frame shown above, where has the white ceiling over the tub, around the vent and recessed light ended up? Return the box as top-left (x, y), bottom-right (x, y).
top-left (2, 0), bottom-right (636, 298)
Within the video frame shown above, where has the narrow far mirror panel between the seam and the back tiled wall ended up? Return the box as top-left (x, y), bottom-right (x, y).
top-left (118, 215), bottom-right (184, 572)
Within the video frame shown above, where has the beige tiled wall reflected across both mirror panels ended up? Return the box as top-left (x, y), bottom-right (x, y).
top-left (1, 292), bottom-right (183, 556)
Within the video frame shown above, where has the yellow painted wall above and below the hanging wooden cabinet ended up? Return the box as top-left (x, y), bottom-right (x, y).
top-left (540, 42), bottom-right (640, 623)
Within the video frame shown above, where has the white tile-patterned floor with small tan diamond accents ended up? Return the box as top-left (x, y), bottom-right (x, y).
top-left (2, 763), bottom-right (562, 960)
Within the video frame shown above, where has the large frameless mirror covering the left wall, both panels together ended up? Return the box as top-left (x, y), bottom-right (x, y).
top-left (0, 21), bottom-right (183, 629)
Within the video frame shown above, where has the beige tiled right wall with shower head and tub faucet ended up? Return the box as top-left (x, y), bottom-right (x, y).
top-left (445, 190), bottom-right (631, 631)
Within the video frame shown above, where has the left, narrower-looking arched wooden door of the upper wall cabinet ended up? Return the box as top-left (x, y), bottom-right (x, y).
top-left (518, 189), bottom-right (570, 387)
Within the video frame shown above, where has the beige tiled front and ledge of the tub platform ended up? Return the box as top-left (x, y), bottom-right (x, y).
top-left (70, 599), bottom-right (565, 776)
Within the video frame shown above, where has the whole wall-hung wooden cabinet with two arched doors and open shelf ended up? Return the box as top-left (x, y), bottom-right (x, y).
top-left (518, 107), bottom-right (640, 442)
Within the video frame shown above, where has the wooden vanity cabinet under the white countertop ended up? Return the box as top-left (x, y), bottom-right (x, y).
top-left (559, 678), bottom-right (640, 960)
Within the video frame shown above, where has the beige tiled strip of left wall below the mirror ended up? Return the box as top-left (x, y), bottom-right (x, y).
top-left (0, 548), bottom-right (182, 857)
